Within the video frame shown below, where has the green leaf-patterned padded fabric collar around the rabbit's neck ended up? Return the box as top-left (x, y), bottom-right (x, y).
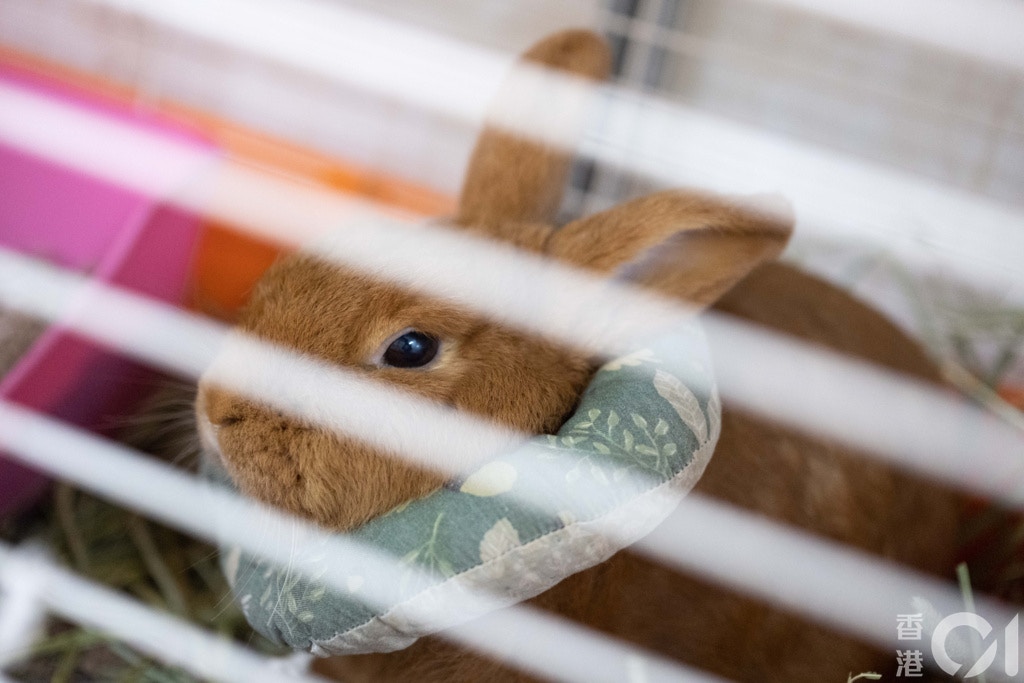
top-left (204, 323), bottom-right (721, 655)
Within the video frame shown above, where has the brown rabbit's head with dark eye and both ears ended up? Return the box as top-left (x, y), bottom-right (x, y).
top-left (197, 31), bottom-right (790, 529)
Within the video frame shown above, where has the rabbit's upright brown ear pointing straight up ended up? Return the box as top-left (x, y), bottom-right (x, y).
top-left (456, 31), bottom-right (610, 226)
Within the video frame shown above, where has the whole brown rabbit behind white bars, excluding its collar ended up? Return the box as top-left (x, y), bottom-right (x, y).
top-left (197, 32), bottom-right (958, 683)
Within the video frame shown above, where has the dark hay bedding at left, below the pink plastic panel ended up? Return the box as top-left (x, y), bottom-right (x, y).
top-left (0, 307), bottom-right (281, 683)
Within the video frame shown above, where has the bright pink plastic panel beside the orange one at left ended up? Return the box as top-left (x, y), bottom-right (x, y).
top-left (0, 66), bottom-right (212, 515)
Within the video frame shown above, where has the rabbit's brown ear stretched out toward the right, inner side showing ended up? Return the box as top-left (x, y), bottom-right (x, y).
top-left (547, 190), bottom-right (794, 306)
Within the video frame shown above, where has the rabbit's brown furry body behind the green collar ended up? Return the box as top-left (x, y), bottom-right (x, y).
top-left (309, 263), bottom-right (961, 683)
